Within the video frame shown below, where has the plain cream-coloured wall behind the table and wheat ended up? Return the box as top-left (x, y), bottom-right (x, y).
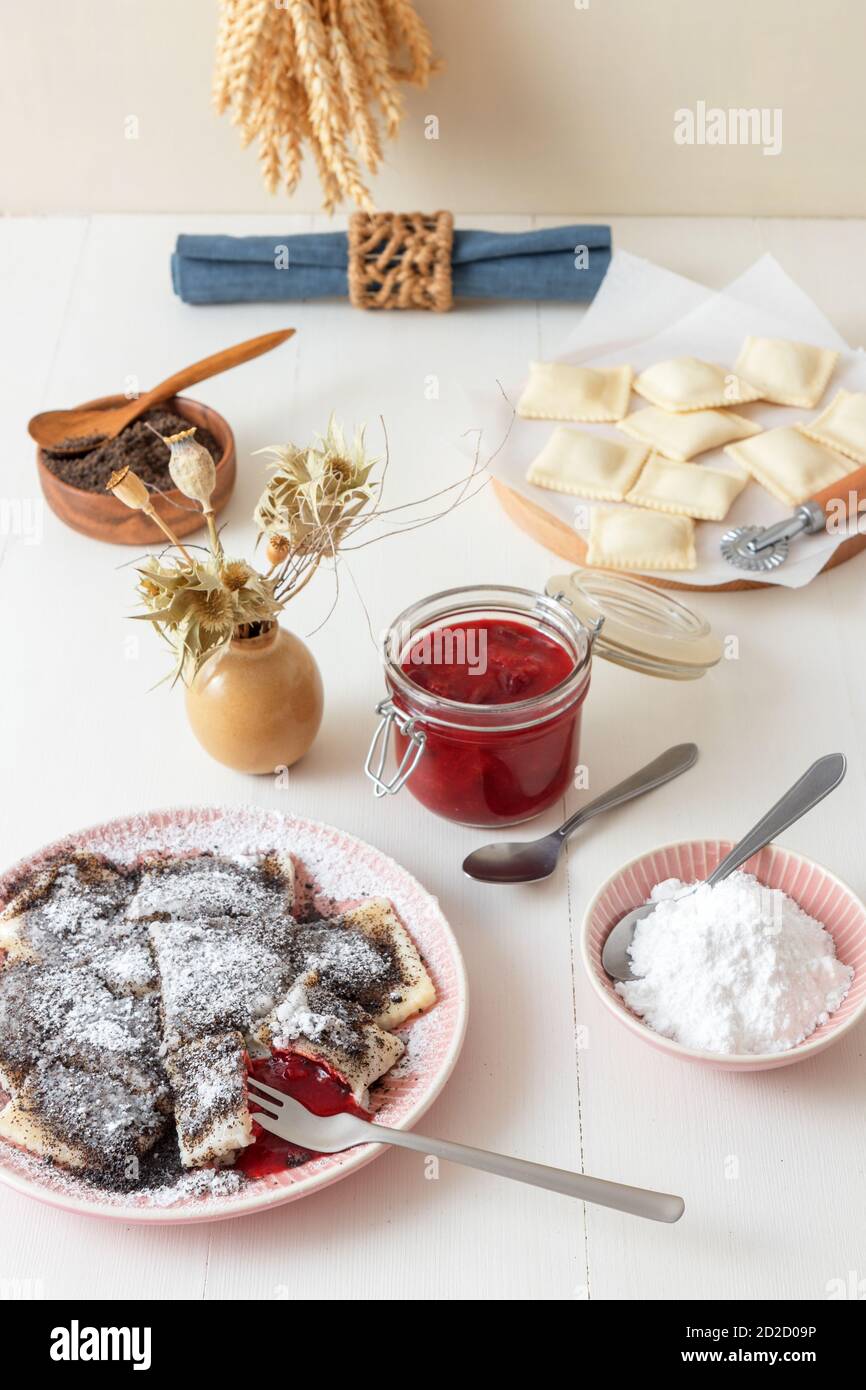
top-left (6, 0), bottom-right (866, 215)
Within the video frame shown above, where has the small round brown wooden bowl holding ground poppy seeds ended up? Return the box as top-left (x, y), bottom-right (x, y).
top-left (36, 396), bottom-right (236, 545)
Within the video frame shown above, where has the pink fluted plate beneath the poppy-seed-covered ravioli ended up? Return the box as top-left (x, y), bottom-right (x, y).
top-left (0, 806), bottom-right (468, 1225)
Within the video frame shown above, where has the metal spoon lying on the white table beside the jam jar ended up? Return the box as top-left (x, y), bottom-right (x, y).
top-left (463, 744), bottom-right (698, 883)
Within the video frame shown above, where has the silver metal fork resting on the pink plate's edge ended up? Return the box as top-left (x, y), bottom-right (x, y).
top-left (247, 1076), bottom-right (685, 1222)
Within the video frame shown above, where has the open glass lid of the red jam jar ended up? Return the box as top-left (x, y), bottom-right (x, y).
top-left (545, 570), bottom-right (723, 681)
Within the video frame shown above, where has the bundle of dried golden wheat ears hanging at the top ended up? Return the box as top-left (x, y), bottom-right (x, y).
top-left (213, 0), bottom-right (436, 211)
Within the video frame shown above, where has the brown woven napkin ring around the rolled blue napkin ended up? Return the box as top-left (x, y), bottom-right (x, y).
top-left (349, 213), bottom-right (455, 314)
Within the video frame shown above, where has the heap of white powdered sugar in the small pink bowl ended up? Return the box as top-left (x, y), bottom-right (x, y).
top-left (616, 873), bottom-right (853, 1055)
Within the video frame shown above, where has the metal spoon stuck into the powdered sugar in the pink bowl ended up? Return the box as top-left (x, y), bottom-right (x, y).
top-left (602, 753), bottom-right (848, 980)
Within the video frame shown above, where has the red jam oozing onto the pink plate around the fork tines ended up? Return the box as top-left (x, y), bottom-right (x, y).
top-left (235, 1048), bottom-right (371, 1177)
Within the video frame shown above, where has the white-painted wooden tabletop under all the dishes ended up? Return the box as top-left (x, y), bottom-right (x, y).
top-left (0, 214), bottom-right (866, 1300)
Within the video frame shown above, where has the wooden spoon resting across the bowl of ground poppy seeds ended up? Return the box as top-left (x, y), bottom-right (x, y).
top-left (28, 328), bottom-right (295, 455)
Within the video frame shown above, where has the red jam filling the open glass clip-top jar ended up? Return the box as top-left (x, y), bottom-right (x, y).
top-left (393, 617), bottom-right (587, 826)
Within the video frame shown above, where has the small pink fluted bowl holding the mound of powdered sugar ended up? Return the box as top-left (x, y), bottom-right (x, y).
top-left (581, 840), bottom-right (866, 1072)
